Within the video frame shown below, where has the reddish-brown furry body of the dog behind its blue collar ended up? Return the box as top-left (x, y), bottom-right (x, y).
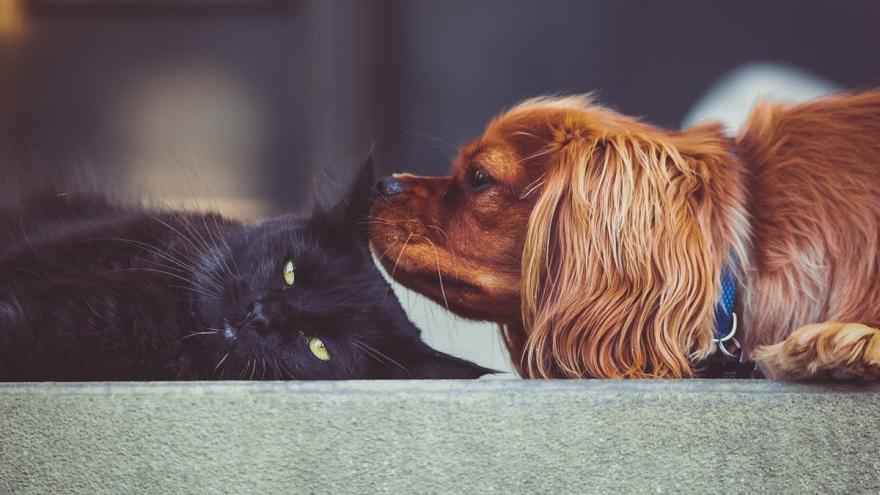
top-left (737, 91), bottom-right (880, 347)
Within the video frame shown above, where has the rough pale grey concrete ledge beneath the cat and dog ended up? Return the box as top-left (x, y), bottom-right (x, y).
top-left (0, 380), bottom-right (880, 494)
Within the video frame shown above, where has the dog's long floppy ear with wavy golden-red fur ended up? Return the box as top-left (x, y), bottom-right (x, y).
top-left (522, 127), bottom-right (729, 378)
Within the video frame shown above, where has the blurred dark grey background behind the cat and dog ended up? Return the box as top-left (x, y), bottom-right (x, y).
top-left (0, 0), bottom-right (880, 370)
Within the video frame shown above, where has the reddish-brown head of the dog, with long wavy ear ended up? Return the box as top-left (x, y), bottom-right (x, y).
top-left (371, 97), bottom-right (746, 377)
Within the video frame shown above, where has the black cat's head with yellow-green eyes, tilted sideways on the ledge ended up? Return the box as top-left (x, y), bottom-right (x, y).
top-left (187, 163), bottom-right (491, 379)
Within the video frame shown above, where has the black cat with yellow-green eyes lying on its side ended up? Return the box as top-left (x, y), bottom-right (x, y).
top-left (0, 164), bottom-right (491, 381)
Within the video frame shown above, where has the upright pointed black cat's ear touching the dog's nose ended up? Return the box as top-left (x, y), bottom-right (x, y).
top-left (316, 156), bottom-right (375, 237)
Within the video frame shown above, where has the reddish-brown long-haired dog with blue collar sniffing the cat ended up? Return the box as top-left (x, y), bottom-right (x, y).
top-left (371, 91), bottom-right (880, 379)
